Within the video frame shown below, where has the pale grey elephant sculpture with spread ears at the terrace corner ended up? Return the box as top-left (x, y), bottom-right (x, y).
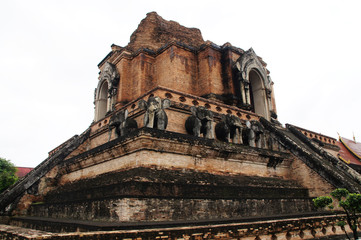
top-left (138, 97), bottom-right (170, 130)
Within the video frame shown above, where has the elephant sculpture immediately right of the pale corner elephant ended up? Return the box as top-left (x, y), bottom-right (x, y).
top-left (185, 106), bottom-right (214, 139)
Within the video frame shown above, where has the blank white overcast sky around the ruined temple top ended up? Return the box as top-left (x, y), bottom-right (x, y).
top-left (0, 0), bottom-right (361, 167)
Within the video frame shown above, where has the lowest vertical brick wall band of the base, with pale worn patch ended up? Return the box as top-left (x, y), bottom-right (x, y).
top-left (30, 198), bottom-right (312, 222)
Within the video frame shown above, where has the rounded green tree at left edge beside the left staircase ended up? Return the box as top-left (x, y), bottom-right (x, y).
top-left (0, 158), bottom-right (18, 193)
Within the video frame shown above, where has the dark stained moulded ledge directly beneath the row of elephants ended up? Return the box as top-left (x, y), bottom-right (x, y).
top-left (63, 128), bottom-right (290, 171)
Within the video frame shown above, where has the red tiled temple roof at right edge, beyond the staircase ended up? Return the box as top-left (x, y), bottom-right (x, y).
top-left (337, 137), bottom-right (361, 165)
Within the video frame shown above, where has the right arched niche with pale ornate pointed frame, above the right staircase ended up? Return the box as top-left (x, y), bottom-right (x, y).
top-left (235, 48), bottom-right (272, 120)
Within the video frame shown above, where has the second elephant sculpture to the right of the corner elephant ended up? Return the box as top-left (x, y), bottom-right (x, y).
top-left (215, 114), bottom-right (243, 144)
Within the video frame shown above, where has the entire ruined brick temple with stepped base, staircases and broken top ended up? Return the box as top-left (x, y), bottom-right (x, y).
top-left (0, 12), bottom-right (361, 239)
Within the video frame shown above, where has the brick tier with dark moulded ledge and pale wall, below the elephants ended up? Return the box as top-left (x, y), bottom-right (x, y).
top-left (59, 128), bottom-right (291, 184)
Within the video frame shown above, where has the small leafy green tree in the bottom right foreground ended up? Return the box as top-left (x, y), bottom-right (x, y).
top-left (313, 188), bottom-right (361, 239)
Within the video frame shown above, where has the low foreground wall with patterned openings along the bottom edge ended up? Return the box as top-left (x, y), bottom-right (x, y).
top-left (0, 213), bottom-right (350, 240)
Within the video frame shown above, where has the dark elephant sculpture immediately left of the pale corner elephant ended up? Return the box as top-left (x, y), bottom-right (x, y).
top-left (109, 109), bottom-right (138, 140)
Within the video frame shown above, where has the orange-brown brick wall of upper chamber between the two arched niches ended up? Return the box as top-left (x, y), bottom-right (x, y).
top-left (100, 35), bottom-right (256, 110)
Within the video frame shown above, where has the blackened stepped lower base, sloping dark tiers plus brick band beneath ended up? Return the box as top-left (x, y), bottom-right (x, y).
top-left (23, 168), bottom-right (312, 222)
